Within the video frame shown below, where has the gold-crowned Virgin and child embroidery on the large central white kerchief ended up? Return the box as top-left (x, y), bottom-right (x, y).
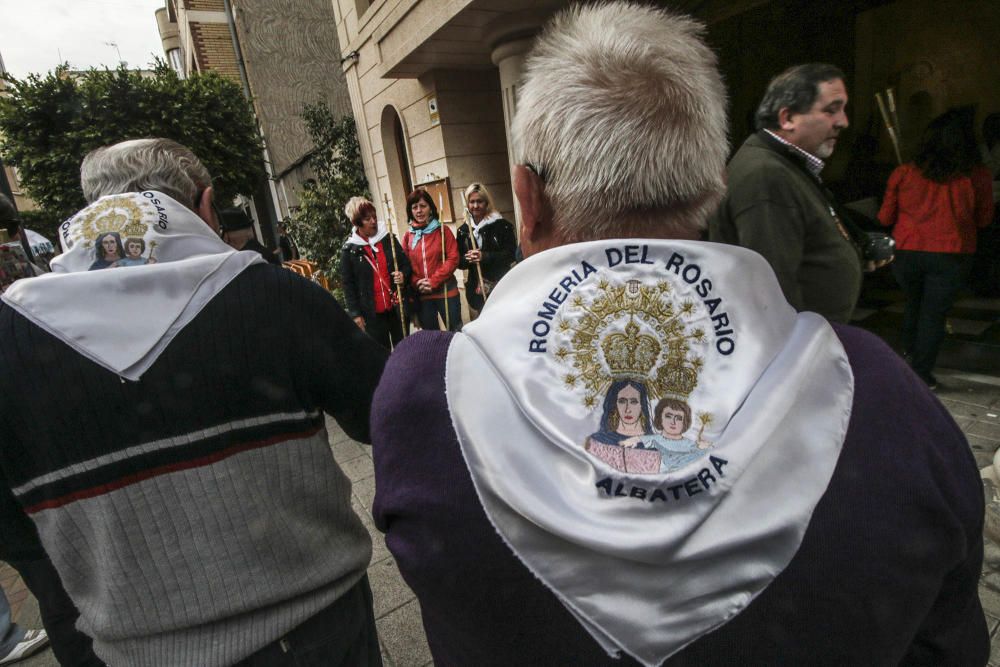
top-left (555, 277), bottom-right (712, 475)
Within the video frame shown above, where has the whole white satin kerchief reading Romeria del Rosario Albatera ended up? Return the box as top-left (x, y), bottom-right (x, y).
top-left (446, 240), bottom-right (853, 665)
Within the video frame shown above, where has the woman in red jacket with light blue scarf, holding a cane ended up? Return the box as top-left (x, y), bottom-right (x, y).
top-left (403, 190), bottom-right (462, 331)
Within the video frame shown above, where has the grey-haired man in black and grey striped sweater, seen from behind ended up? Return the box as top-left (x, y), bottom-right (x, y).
top-left (0, 139), bottom-right (386, 667)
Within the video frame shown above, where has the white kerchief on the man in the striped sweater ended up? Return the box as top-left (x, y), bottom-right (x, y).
top-left (3, 192), bottom-right (264, 381)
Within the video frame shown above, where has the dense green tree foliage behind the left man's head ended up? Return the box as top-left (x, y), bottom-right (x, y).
top-left (0, 61), bottom-right (264, 217)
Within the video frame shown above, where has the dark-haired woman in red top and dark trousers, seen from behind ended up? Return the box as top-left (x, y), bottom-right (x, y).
top-left (878, 111), bottom-right (993, 388)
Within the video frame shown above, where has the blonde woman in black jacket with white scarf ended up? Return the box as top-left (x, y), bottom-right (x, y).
top-left (456, 183), bottom-right (517, 319)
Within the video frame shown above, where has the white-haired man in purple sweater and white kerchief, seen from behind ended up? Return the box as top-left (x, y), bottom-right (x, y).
top-left (372, 2), bottom-right (989, 667)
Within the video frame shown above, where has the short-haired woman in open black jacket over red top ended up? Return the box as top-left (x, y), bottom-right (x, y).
top-left (340, 197), bottom-right (411, 349)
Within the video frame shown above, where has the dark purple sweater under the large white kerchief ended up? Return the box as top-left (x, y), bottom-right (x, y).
top-left (372, 325), bottom-right (989, 667)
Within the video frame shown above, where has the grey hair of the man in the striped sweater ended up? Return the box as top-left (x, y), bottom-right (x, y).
top-left (80, 139), bottom-right (212, 209)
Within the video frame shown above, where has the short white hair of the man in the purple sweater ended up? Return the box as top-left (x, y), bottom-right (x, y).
top-left (512, 2), bottom-right (728, 242)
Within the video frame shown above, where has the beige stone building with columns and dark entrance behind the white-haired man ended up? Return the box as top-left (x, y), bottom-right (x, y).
top-left (332, 0), bottom-right (1000, 231)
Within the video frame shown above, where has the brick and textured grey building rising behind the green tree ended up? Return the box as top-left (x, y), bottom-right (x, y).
top-left (156, 0), bottom-right (351, 226)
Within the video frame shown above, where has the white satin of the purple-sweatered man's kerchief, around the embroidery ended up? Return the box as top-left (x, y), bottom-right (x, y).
top-left (446, 240), bottom-right (853, 666)
